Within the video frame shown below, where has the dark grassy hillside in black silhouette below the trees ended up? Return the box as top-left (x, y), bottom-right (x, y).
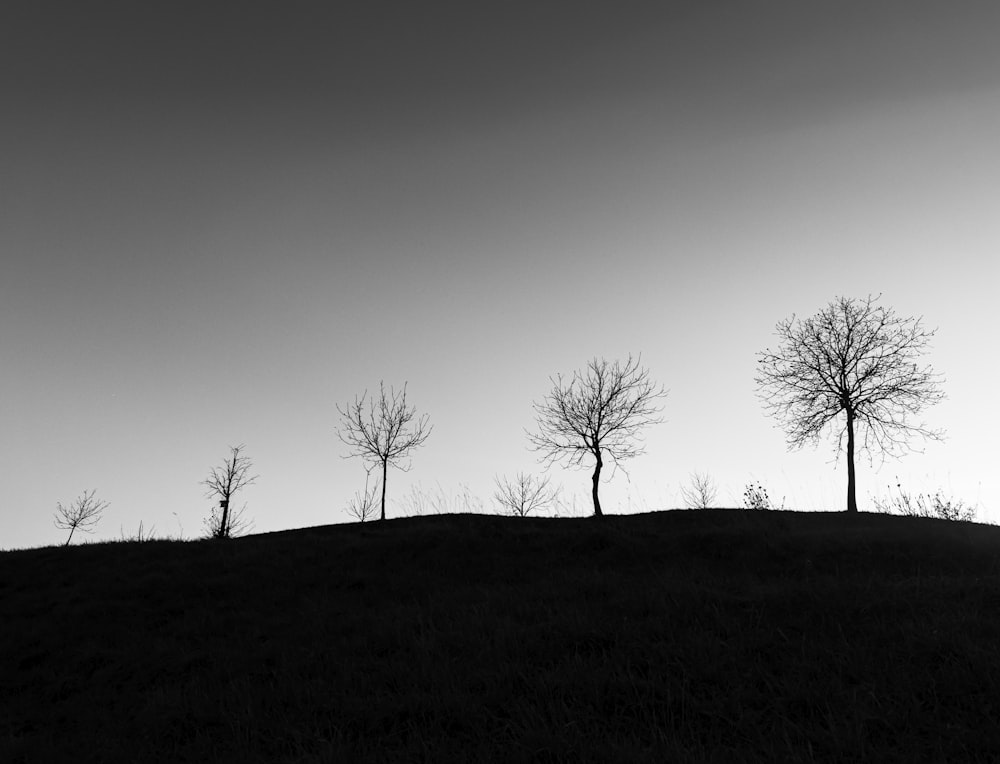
top-left (0, 510), bottom-right (1000, 763)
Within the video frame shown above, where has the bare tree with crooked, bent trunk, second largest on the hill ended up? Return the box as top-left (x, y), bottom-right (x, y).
top-left (528, 355), bottom-right (667, 517)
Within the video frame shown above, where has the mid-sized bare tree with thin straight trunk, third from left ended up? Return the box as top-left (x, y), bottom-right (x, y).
top-left (337, 382), bottom-right (434, 520)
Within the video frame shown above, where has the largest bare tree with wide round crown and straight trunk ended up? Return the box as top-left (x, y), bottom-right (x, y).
top-left (756, 296), bottom-right (944, 512)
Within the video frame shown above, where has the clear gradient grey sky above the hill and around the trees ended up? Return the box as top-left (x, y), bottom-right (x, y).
top-left (0, 0), bottom-right (1000, 548)
